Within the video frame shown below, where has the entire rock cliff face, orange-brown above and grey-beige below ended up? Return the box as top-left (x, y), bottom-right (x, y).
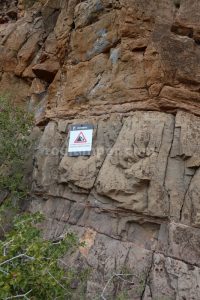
top-left (0, 0), bottom-right (200, 300)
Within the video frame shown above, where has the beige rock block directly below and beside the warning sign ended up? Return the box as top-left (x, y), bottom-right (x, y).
top-left (59, 118), bottom-right (121, 189)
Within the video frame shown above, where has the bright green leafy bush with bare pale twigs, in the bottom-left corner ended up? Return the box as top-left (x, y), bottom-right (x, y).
top-left (0, 214), bottom-right (85, 300)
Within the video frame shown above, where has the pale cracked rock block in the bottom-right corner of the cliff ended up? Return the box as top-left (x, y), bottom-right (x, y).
top-left (148, 254), bottom-right (200, 300)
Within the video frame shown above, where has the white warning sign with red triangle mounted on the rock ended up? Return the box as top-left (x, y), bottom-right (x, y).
top-left (68, 124), bottom-right (93, 156)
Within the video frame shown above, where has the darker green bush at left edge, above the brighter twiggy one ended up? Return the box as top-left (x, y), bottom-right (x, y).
top-left (0, 96), bottom-right (32, 203)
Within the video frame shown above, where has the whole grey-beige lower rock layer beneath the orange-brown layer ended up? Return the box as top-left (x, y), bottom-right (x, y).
top-left (28, 111), bottom-right (200, 299)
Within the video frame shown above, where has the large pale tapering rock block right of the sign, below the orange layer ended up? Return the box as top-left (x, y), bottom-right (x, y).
top-left (96, 113), bottom-right (173, 217)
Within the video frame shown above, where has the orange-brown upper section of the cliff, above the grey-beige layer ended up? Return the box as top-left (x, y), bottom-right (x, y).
top-left (0, 0), bottom-right (200, 118)
